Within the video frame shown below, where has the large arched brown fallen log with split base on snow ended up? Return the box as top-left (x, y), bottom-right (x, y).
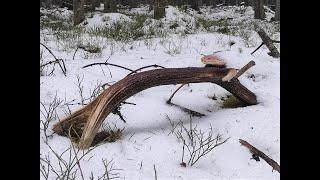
top-left (53, 67), bottom-right (257, 149)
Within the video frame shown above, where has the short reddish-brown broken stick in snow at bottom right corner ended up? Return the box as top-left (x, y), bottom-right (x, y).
top-left (239, 139), bottom-right (280, 173)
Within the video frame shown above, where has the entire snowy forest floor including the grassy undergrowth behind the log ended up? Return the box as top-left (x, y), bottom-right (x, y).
top-left (40, 6), bottom-right (280, 180)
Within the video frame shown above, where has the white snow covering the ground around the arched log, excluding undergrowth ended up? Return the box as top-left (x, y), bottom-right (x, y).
top-left (40, 4), bottom-right (280, 180)
